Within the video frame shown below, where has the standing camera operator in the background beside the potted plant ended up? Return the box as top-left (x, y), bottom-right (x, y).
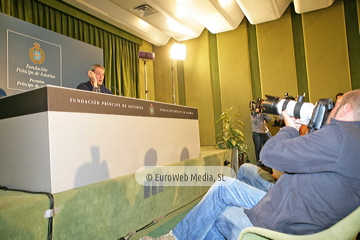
top-left (250, 98), bottom-right (271, 164)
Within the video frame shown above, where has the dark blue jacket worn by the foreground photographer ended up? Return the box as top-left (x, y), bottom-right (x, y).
top-left (245, 119), bottom-right (360, 235)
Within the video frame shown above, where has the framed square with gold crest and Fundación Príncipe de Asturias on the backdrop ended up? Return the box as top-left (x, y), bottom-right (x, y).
top-left (7, 30), bottom-right (62, 90)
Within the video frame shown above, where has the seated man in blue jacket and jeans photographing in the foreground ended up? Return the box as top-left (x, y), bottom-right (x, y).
top-left (142, 89), bottom-right (360, 240)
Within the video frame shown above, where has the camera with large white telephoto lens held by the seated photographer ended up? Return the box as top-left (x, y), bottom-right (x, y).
top-left (261, 95), bottom-right (334, 130)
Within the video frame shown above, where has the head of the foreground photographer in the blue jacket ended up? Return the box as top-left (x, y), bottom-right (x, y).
top-left (327, 89), bottom-right (360, 123)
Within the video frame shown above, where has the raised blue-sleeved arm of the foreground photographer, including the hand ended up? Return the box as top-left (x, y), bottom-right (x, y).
top-left (260, 119), bottom-right (342, 173)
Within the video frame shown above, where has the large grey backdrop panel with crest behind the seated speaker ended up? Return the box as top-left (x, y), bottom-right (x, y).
top-left (0, 13), bottom-right (103, 98)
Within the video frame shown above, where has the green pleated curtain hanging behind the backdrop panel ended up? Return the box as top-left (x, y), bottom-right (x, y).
top-left (0, 0), bottom-right (140, 97)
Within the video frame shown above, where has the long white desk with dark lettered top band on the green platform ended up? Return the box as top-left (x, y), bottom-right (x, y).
top-left (0, 85), bottom-right (200, 193)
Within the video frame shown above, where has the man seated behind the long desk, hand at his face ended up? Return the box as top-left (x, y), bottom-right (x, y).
top-left (76, 64), bottom-right (112, 94)
